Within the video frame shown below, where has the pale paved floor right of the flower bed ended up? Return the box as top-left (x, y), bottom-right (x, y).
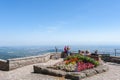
top-left (82, 63), bottom-right (120, 80)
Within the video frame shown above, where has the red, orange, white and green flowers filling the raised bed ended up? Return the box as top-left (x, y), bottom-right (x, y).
top-left (55, 55), bottom-right (99, 71)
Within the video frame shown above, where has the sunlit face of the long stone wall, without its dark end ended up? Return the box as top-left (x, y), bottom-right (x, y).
top-left (7, 53), bottom-right (51, 70)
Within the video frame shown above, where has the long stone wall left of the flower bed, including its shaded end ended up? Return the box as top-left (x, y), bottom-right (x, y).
top-left (0, 53), bottom-right (53, 70)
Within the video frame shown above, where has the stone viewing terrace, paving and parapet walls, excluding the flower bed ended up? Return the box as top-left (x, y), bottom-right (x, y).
top-left (0, 53), bottom-right (120, 80)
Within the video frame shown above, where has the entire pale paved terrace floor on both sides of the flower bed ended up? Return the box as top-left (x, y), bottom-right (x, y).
top-left (0, 60), bottom-right (120, 80)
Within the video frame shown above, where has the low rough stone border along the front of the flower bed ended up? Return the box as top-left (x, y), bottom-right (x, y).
top-left (34, 65), bottom-right (109, 80)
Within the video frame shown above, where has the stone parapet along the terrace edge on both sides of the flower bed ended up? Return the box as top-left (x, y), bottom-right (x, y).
top-left (0, 53), bottom-right (120, 71)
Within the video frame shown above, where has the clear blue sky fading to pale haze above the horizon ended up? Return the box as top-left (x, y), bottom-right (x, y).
top-left (0, 0), bottom-right (120, 46)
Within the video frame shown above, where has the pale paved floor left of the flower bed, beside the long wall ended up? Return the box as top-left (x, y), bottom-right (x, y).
top-left (0, 59), bottom-right (65, 80)
